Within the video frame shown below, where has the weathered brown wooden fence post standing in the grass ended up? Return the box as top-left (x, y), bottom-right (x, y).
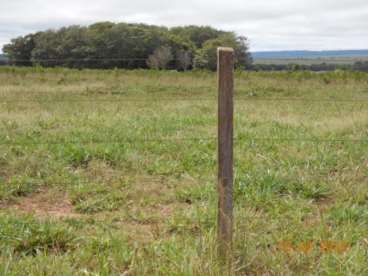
top-left (217, 48), bottom-right (234, 259)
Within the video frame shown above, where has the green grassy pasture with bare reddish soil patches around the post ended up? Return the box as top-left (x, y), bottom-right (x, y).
top-left (0, 67), bottom-right (368, 275)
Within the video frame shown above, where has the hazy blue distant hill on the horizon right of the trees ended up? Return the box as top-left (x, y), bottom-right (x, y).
top-left (252, 49), bottom-right (368, 59)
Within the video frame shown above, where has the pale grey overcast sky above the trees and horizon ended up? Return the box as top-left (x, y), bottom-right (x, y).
top-left (0, 0), bottom-right (368, 51)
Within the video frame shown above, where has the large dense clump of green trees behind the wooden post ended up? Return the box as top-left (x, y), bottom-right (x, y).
top-left (3, 22), bottom-right (252, 71)
